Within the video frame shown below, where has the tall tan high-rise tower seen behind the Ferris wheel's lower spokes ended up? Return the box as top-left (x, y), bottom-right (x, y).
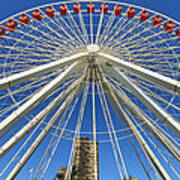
top-left (71, 136), bottom-right (99, 180)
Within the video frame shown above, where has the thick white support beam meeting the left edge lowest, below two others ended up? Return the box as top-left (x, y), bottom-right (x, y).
top-left (0, 77), bottom-right (80, 158)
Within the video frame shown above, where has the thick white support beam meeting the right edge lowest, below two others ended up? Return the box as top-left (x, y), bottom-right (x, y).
top-left (108, 80), bottom-right (180, 161)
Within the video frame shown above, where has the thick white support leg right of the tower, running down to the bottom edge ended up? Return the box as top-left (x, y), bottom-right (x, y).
top-left (103, 75), bottom-right (171, 180)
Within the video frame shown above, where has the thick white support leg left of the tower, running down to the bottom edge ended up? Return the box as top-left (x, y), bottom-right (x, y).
top-left (6, 91), bottom-right (73, 180)
